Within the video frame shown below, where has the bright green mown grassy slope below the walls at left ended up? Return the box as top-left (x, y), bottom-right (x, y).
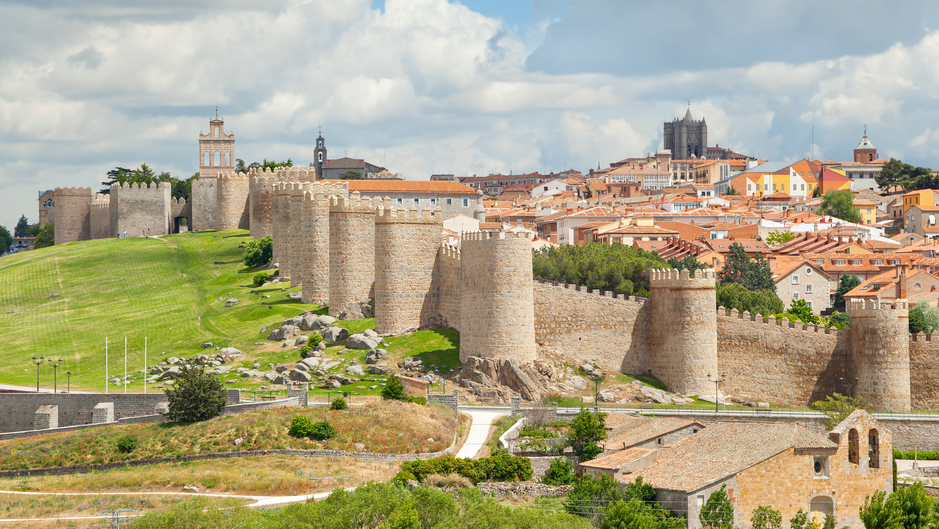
top-left (0, 231), bottom-right (316, 390)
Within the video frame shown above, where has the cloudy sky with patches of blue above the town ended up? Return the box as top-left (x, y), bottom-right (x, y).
top-left (0, 0), bottom-right (939, 228)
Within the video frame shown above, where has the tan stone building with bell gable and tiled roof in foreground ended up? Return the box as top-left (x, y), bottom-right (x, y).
top-left (637, 410), bottom-right (893, 529)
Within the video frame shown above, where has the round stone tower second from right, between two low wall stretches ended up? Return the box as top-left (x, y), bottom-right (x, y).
top-left (649, 270), bottom-right (720, 395)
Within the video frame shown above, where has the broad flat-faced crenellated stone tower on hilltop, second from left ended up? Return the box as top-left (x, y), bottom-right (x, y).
top-left (110, 182), bottom-right (172, 237)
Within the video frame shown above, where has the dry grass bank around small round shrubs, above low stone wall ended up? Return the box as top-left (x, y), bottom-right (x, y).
top-left (0, 401), bottom-right (458, 469)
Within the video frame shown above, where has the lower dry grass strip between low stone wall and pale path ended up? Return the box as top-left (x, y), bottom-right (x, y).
top-left (0, 456), bottom-right (401, 496)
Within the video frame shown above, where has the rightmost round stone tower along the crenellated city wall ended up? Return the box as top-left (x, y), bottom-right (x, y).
top-left (848, 299), bottom-right (912, 413)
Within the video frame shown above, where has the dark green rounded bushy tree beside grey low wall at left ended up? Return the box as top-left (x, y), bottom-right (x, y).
top-left (166, 366), bottom-right (228, 422)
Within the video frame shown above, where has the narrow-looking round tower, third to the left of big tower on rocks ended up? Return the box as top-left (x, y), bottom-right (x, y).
top-left (300, 182), bottom-right (349, 305)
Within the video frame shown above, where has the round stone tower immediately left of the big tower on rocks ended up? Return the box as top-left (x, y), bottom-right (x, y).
top-left (375, 202), bottom-right (443, 334)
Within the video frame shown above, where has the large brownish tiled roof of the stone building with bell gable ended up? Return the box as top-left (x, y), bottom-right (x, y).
top-left (637, 421), bottom-right (838, 492)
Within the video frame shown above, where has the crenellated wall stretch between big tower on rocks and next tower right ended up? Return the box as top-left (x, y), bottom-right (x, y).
top-left (534, 279), bottom-right (650, 373)
